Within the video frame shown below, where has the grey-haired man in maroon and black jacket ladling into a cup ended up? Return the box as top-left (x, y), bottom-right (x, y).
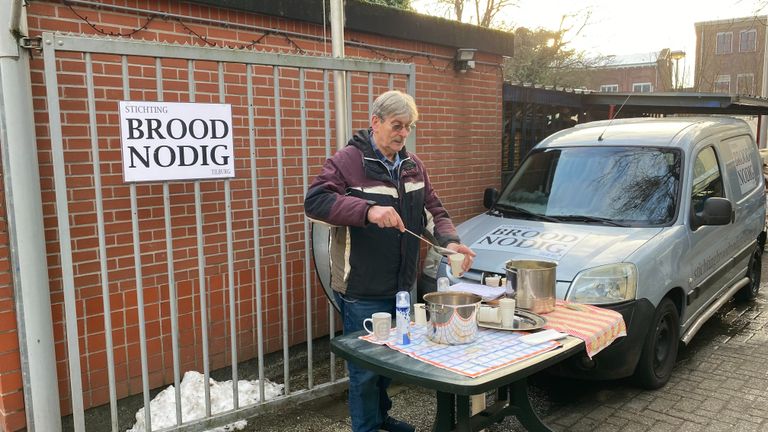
top-left (304, 90), bottom-right (475, 432)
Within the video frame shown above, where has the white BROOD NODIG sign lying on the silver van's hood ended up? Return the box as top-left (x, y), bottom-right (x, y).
top-left (470, 224), bottom-right (584, 261)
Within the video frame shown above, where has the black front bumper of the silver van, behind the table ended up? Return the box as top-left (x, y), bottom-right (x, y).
top-left (548, 299), bottom-right (655, 380)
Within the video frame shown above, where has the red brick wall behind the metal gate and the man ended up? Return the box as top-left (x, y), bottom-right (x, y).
top-left (0, 0), bottom-right (502, 430)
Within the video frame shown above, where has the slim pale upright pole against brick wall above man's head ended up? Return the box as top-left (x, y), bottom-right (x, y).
top-left (331, 0), bottom-right (348, 149)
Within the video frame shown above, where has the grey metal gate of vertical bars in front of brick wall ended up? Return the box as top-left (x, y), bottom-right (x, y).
top-left (41, 33), bottom-right (415, 431)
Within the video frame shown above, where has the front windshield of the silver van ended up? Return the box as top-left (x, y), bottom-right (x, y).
top-left (495, 147), bottom-right (681, 226)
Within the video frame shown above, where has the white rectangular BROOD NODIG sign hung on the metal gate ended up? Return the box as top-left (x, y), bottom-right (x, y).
top-left (120, 101), bottom-right (235, 183)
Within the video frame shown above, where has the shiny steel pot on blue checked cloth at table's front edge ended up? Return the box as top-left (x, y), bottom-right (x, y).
top-left (424, 291), bottom-right (483, 345)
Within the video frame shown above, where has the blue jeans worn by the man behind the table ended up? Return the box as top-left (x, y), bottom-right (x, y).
top-left (333, 291), bottom-right (395, 432)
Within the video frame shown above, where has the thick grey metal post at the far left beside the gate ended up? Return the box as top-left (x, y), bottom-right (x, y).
top-left (0, 0), bottom-right (61, 432)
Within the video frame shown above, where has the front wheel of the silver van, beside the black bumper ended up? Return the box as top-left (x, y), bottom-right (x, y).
top-left (634, 298), bottom-right (680, 390)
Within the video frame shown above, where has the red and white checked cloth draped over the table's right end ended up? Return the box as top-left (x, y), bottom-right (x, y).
top-left (542, 300), bottom-right (627, 358)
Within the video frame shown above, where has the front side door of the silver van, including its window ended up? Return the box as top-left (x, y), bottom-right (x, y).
top-left (682, 145), bottom-right (733, 325)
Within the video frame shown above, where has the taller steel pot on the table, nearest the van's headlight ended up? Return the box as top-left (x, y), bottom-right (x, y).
top-left (505, 260), bottom-right (557, 313)
